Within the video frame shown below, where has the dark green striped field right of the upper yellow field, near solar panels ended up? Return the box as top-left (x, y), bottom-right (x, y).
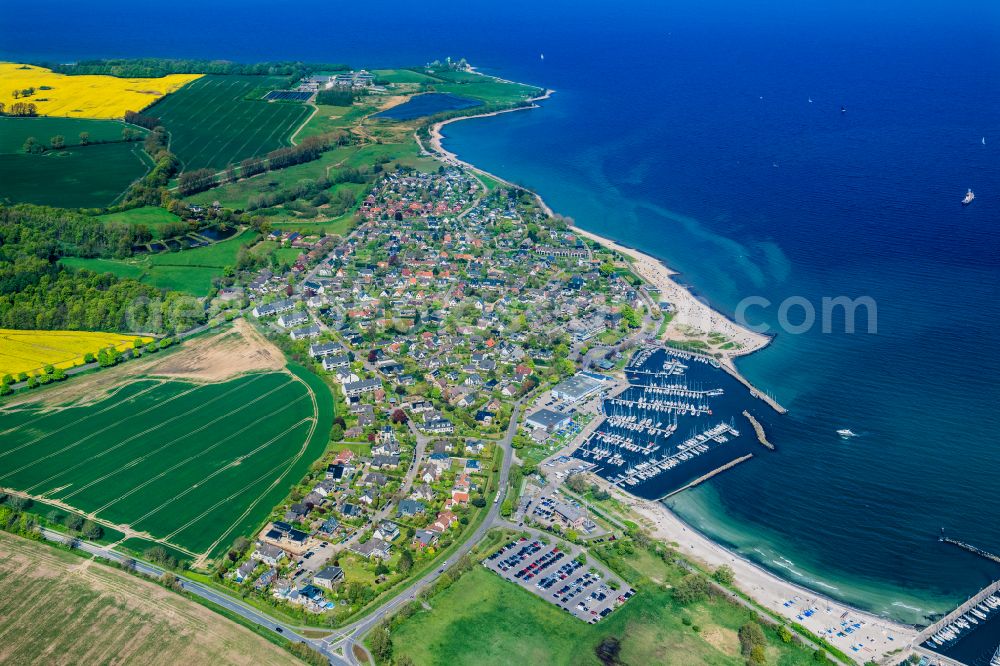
top-left (144, 76), bottom-right (311, 169)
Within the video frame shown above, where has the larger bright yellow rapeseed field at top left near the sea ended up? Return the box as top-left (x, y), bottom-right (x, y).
top-left (0, 62), bottom-right (201, 118)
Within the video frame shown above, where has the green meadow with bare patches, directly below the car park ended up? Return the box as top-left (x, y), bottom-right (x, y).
top-left (392, 548), bottom-right (812, 666)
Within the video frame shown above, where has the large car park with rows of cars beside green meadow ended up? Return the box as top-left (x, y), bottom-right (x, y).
top-left (483, 536), bottom-right (635, 624)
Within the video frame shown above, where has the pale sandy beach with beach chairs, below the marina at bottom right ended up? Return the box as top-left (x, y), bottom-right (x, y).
top-left (620, 484), bottom-right (917, 663)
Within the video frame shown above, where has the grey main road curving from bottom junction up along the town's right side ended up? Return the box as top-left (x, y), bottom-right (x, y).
top-left (332, 398), bottom-right (525, 664)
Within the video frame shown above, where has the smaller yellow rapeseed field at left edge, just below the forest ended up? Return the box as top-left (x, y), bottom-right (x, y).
top-left (0, 328), bottom-right (152, 377)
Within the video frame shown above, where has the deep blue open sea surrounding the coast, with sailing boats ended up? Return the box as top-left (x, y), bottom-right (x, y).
top-left (0, 0), bottom-right (1000, 621)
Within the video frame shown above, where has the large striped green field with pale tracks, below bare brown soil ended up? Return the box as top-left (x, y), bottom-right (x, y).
top-left (0, 366), bottom-right (333, 556)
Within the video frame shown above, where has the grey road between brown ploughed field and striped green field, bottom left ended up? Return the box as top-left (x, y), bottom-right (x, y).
top-left (42, 528), bottom-right (347, 666)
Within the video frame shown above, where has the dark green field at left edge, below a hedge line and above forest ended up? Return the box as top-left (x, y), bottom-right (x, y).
top-left (0, 143), bottom-right (149, 208)
